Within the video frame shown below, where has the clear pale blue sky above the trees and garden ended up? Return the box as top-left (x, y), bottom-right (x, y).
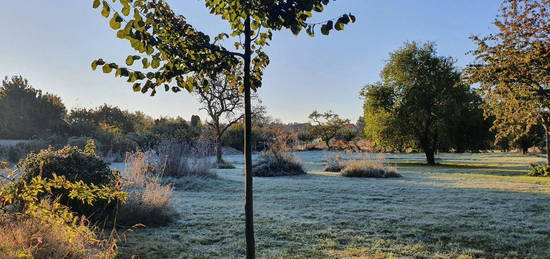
top-left (0, 0), bottom-right (501, 122)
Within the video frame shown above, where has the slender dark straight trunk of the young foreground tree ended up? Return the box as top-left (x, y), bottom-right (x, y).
top-left (244, 15), bottom-right (256, 259)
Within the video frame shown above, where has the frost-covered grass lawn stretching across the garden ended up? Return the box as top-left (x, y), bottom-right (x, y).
top-left (115, 152), bottom-right (550, 258)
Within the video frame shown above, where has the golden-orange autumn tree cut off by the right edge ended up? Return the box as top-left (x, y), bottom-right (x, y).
top-left (466, 0), bottom-right (550, 164)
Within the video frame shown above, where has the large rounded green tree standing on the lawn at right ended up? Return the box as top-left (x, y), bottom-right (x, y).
top-left (361, 42), bottom-right (490, 165)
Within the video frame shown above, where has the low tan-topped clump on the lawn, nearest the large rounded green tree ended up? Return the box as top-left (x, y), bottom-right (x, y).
top-left (341, 155), bottom-right (401, 178)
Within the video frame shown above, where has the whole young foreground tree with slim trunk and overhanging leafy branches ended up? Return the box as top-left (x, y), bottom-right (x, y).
top-left (92, 0), bottom-right (355, 258)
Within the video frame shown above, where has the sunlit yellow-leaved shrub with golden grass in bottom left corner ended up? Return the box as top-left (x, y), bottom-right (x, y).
top-left (0, 165), bottom-right (127, 258)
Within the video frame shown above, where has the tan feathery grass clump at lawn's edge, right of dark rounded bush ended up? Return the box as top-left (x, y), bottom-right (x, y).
top-left (117, 152), bottom-right (175, 226)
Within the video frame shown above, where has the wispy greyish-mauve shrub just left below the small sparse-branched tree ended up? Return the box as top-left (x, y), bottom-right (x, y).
top-left (156, 141), bottom-right (216, 178)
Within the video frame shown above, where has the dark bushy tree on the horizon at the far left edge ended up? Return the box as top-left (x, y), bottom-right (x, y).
top-left (0, 76), bottom-right (66, 139)
